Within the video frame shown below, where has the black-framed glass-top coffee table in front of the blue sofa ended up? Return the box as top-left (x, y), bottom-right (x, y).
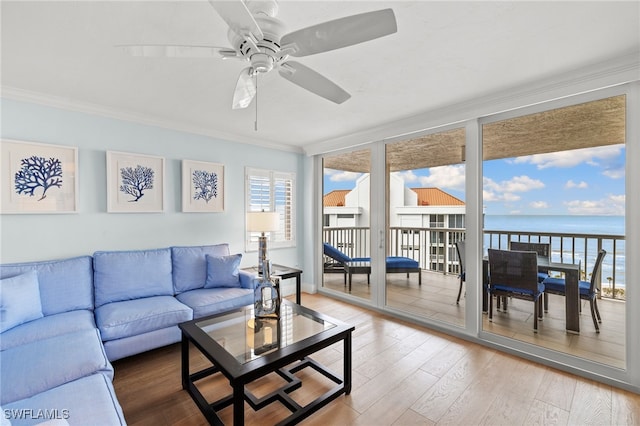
top-left (179, 300), bottom-right (354, 425)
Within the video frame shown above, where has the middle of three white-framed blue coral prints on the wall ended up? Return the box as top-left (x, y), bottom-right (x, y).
top-left (107, 151), bottom-right (164, 213)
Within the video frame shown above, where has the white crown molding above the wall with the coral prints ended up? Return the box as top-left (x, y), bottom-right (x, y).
top-left (0, 86), bottom-right (303, 154)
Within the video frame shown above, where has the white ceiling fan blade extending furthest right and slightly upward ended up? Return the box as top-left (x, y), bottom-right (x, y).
top-left (280, 9), bottom-right (398, 57)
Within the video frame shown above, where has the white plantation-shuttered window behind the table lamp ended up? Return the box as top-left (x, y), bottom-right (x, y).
top-left (246, 167), bottom-right (296, 251)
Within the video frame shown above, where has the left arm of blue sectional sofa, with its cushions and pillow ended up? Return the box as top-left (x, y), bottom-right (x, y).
top-left (0, 256), bottom-right (125, 425)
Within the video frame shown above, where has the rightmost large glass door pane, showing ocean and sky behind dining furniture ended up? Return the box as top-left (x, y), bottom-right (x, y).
top-left (482, 95), bottom-right (626, 368)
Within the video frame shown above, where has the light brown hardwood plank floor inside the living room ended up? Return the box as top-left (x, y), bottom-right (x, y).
top-left (113, 294), bottom-right (640, 426)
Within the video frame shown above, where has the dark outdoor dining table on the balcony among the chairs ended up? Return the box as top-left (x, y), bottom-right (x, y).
top-left (482, 256), bottom-right (580, 334)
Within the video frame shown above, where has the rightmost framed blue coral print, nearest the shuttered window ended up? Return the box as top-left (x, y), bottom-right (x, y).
top-left (182, 160), bottom-right (224, 212)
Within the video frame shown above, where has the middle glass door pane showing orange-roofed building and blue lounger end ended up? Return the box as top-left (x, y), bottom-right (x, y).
top-left (385, 128), bottom-right (465, 326)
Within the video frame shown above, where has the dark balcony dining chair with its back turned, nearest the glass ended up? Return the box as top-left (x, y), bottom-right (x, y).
top-left (488, 249), bottom-right (545, 333)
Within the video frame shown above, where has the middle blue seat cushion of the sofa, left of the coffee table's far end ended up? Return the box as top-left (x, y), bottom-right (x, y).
top-left (95, 296), bottom-right (193, 341)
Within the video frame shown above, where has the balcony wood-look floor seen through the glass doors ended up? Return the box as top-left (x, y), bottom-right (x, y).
top-left (324, 271), bottom-right (626, 368)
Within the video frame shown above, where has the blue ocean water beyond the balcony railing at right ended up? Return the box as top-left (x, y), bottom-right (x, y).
top-left (484, 215), bottom-right (625, 288)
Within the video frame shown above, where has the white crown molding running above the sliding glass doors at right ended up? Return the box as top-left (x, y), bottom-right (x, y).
top-left (303, 51), bottom-right (640, 155)
